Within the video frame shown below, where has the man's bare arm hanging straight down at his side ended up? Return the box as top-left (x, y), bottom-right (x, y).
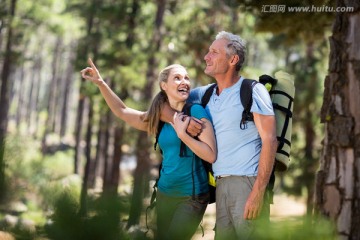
top-left (244, 113), bottom-right (278, 219)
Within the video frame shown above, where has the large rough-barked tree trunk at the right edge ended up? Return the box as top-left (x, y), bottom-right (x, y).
top-left (316, 0), bottom-right (360, 239)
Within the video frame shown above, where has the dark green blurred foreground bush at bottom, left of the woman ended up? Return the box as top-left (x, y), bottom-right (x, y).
top-left (45, 191), bottom-right (129, 240)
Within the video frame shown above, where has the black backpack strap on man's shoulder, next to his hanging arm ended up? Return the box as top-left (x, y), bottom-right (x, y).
top-left (240, 79), bottom-right (258, 130)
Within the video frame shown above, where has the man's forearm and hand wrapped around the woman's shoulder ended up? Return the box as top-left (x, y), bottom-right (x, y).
top-left (160, 103), bottom-right (203, 137)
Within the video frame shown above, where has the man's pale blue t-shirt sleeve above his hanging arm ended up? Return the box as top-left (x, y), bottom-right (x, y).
top-left (250, 84), bottom-right (274, 115)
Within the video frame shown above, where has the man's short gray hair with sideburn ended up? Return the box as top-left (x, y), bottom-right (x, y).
top-left (215, 31), bottom-right (246, 71)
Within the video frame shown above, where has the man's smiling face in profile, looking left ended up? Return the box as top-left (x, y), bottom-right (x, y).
top-left (204, 39), bottom-right (230, 78)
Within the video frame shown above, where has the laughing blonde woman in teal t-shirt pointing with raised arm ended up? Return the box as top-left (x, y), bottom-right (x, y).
top-left (81, 59), bottom-right (217, 240)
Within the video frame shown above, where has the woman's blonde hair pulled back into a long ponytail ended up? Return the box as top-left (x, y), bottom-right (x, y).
top-left (145, 64), bottom-right (184, 135)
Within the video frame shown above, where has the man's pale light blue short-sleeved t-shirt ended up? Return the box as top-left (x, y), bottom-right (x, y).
top-left (188, 77), bottom-right (274, 176)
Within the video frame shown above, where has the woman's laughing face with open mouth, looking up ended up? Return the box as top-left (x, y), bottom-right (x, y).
top-left (161, 67), bottom-right (191, 101)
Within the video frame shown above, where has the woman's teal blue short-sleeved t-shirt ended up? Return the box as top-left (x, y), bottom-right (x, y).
top-left (158, 104), bottom-right (210, 197)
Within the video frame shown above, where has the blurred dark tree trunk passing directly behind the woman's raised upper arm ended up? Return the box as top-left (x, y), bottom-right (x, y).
top-left (127, 0), bottom-right (166, 228)
